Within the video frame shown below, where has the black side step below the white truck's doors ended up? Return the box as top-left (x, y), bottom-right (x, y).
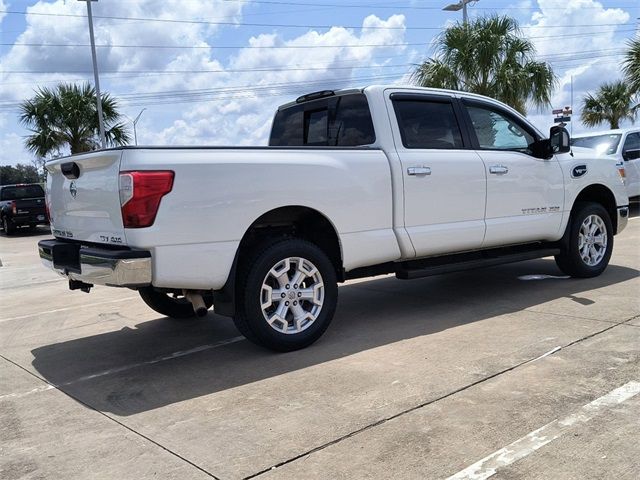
top-left (396, 247), bottom-right (560, 280)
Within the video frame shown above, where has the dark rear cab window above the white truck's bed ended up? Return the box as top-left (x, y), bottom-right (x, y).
top-left (269, 93), bottom-right (376, 147)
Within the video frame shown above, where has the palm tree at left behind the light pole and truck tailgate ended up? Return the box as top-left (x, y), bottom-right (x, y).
top-left (19, 83), bottom-right (130, 157)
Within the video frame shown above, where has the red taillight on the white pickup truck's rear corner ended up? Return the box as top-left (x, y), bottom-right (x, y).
top-left (120, 170), bottom-right (174, 228)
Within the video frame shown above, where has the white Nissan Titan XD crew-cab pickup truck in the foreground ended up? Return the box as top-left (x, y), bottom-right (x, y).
top-left (39, 86), bottom-right (629, 351)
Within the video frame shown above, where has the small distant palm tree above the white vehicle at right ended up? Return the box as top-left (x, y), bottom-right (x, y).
top-left (581, 80), bottom-right (636, 129)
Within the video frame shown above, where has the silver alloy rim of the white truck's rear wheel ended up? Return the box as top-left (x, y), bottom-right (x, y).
top-left (260, 257), bottom-right (325, 334)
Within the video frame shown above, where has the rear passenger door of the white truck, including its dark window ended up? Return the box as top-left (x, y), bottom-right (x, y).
top-left (388, 93), bottom-right (486, 257)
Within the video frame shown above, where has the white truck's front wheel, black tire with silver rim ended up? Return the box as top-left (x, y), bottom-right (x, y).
top-left (555, 202), bottom-right (613, 278)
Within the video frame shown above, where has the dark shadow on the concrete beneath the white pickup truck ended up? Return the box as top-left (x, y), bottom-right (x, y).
top-left (32, 259), bottom-right (639, 416)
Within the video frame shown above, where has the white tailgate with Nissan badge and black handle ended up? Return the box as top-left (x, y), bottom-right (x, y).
top-left (46, 150), bottom-right (126, 245)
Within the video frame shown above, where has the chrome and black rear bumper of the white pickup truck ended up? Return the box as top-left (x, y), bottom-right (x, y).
top-left (38, 239), bottom-right (152, 287)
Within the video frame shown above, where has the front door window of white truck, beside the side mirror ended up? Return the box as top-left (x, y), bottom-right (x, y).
top-left (467, 105), bottom-right (535, 154)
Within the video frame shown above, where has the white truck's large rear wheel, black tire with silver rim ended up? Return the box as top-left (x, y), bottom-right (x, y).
top-left (234, 239), bottom-right (338, 352)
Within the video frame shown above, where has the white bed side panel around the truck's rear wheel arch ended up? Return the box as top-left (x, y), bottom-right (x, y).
top-left (121, 148), bottom-right (400, 288)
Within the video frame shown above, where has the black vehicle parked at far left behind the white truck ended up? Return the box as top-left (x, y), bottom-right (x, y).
top-left (0, 183), bottom-right (49, 235)
